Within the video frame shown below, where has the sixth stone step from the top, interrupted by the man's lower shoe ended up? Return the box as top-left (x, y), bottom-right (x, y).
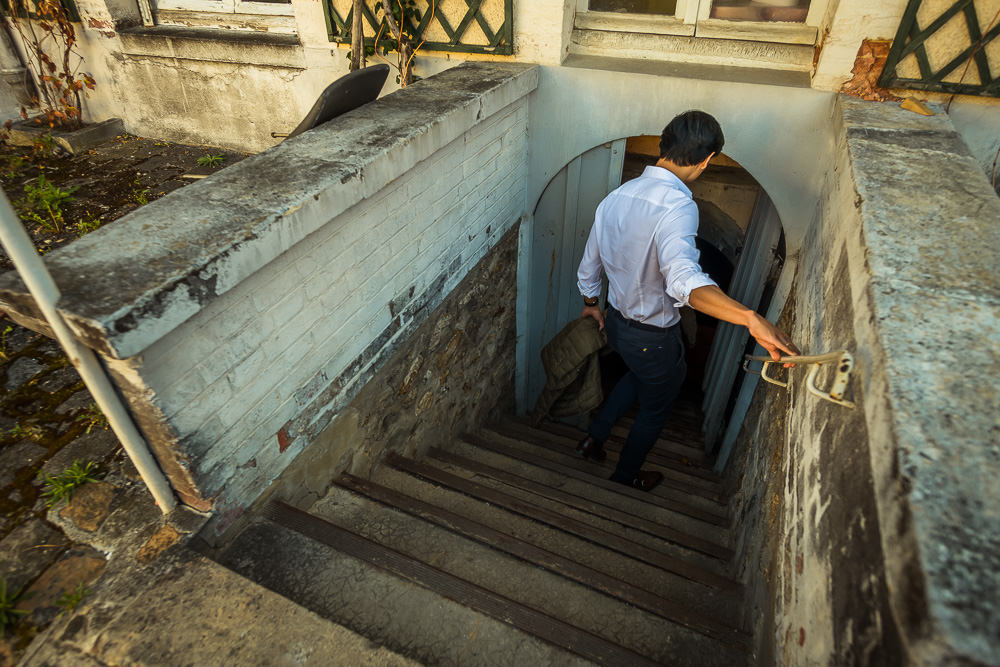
top-left (480, 421), bottom-right (729, 519)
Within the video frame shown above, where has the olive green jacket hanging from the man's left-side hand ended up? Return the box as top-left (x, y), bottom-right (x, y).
top-left (531, 317), bottom-right (607, 424)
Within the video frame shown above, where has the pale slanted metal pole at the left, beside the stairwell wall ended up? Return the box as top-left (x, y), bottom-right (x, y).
top-left (0, 194), bottom-right (177, 514)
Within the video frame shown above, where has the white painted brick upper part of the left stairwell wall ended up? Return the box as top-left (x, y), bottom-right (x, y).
top-left (141, 98), bottom-right (528, 507)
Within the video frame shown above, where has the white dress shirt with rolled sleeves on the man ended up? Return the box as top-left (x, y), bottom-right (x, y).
top-left (577, 166), bottom-right (716, 327)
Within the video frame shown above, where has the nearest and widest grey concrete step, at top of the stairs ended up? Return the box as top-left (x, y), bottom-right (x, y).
top-left (219, 510), bottom-right (608, 667)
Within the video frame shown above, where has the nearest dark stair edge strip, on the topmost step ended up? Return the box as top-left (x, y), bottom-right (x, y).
top-left (263, 501), bottom-right (657, 667)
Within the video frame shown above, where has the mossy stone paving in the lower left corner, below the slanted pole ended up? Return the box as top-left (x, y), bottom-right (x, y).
top-left (0, 316), bottom-right (124, 664)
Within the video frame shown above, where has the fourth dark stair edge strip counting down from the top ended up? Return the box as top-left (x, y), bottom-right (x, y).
top-left (429, 447), bottom-right (733, 561)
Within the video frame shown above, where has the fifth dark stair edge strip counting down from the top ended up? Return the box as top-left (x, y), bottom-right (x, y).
top-left (461, 433), bottom-right (730, 528)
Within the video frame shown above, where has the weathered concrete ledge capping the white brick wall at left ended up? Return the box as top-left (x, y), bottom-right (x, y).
top-left (0, 62), bottom-right (538, 359)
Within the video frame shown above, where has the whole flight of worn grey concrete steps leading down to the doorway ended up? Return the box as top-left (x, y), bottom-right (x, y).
top-left (218, 410), bottom-right (749, 667)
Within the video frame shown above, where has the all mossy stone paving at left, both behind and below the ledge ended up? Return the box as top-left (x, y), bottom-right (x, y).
top-left (0, 130), bottom-right (246, 667)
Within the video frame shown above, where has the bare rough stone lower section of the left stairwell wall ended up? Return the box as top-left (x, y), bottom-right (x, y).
top-left (268, 227), bottom-right (518, 507)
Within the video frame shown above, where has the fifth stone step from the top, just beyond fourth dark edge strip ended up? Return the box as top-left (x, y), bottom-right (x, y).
top-left (451, 434), bottom-right (729, 546)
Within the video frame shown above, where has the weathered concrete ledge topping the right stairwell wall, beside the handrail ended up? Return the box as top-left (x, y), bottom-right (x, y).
top-left (839, 97), bottom-right (1000, 664)
